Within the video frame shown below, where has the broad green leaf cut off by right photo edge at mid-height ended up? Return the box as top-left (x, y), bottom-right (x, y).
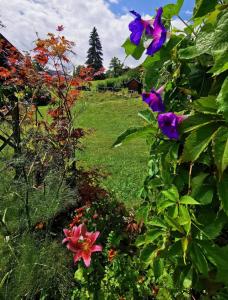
top-left (212, 126), bottom-right (228, 177)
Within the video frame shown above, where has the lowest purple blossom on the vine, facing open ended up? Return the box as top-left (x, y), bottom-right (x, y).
top-left (158, 112), bottom-right (184, 140)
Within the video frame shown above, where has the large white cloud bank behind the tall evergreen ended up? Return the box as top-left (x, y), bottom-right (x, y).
top-left (0, 0), bottom-right (132, 66)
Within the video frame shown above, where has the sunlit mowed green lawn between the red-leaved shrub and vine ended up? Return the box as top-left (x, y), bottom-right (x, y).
top-left (75, 92), bottom-right (149, 205)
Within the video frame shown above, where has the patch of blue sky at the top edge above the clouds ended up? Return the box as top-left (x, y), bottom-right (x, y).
top-left (109, 0), bottom-right (194, 18)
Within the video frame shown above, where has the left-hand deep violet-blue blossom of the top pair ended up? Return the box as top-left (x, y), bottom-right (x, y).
top-left (129, 10), bottom-right (153, 46)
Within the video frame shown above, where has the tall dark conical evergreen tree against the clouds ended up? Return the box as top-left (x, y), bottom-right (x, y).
top-left (86, 27), bottom-right (103, 71)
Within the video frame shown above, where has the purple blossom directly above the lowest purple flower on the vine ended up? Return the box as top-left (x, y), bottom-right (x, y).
top-left (142, 86), bottom-right (165, 112)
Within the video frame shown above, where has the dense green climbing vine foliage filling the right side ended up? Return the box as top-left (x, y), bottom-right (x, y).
top-left (117, 0), bottom-right (228, 299)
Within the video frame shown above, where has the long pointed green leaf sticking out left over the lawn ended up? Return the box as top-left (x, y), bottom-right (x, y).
top-left (112, 126), bottom-right (156, 147)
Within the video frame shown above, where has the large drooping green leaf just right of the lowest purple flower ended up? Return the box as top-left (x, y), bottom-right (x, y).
top-left (181, 124), bottom-right (219, 162)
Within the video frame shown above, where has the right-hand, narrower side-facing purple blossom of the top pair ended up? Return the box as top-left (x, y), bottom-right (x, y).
top-left (146, 7), bottom-right (167, 55)
